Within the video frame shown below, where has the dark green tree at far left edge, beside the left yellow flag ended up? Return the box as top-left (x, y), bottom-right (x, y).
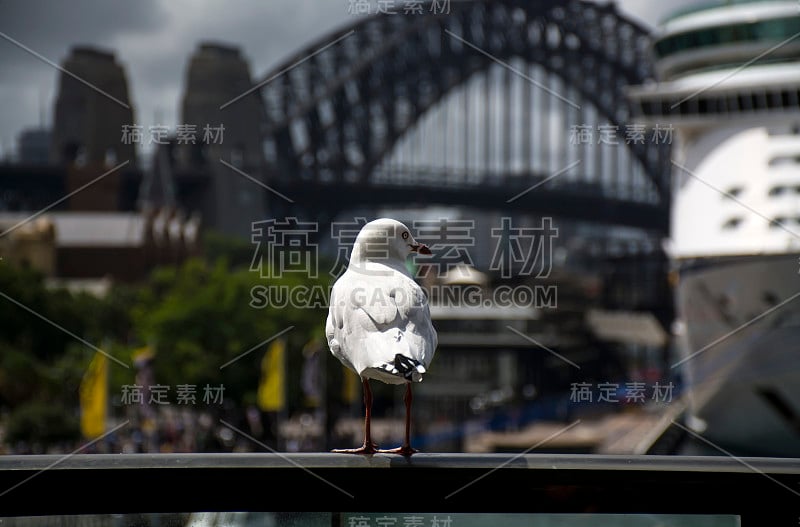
top-left (0, 263), bottom-right (128, 443)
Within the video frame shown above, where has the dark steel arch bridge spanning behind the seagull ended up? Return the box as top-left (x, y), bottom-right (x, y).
top-left (259, 0), bottom-right (671, 233)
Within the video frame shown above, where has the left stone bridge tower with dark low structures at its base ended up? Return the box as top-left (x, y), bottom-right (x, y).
top-left (0, 47), bottom-right (142, 213)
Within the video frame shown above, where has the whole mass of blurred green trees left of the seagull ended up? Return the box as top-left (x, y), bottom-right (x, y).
top-left (0, 235), bottom-right (338, 452)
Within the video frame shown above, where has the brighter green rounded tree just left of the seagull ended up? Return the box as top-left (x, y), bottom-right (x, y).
top-left (131, 258), bottom-right (328, 410)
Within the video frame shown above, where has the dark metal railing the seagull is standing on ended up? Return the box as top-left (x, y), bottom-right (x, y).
top-left (0, 453), bottom-right (800, 526)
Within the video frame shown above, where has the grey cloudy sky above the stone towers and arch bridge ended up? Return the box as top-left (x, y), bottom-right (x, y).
top-left (0, 0), bottom-right (697, 157)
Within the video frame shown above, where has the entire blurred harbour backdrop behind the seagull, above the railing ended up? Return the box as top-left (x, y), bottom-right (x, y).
top-left (0, 0), bottom-right (800, 466)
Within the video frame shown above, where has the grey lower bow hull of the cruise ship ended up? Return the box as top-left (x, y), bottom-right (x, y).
top-left (677, 254), bottom-right (800, 457)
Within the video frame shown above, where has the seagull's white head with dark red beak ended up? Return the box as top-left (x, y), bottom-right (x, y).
top-left (350, 218), bottom-right (431, 262)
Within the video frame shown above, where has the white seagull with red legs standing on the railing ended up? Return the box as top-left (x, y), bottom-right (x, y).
top-left (325, 218), bottom-right (438, 456)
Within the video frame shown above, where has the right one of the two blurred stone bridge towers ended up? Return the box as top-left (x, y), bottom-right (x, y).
top-left (142, 43), bottom-right (265, 237)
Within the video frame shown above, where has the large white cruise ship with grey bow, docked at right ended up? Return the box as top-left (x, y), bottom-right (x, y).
top-left (629, 0), bottom-right (800, 457)
